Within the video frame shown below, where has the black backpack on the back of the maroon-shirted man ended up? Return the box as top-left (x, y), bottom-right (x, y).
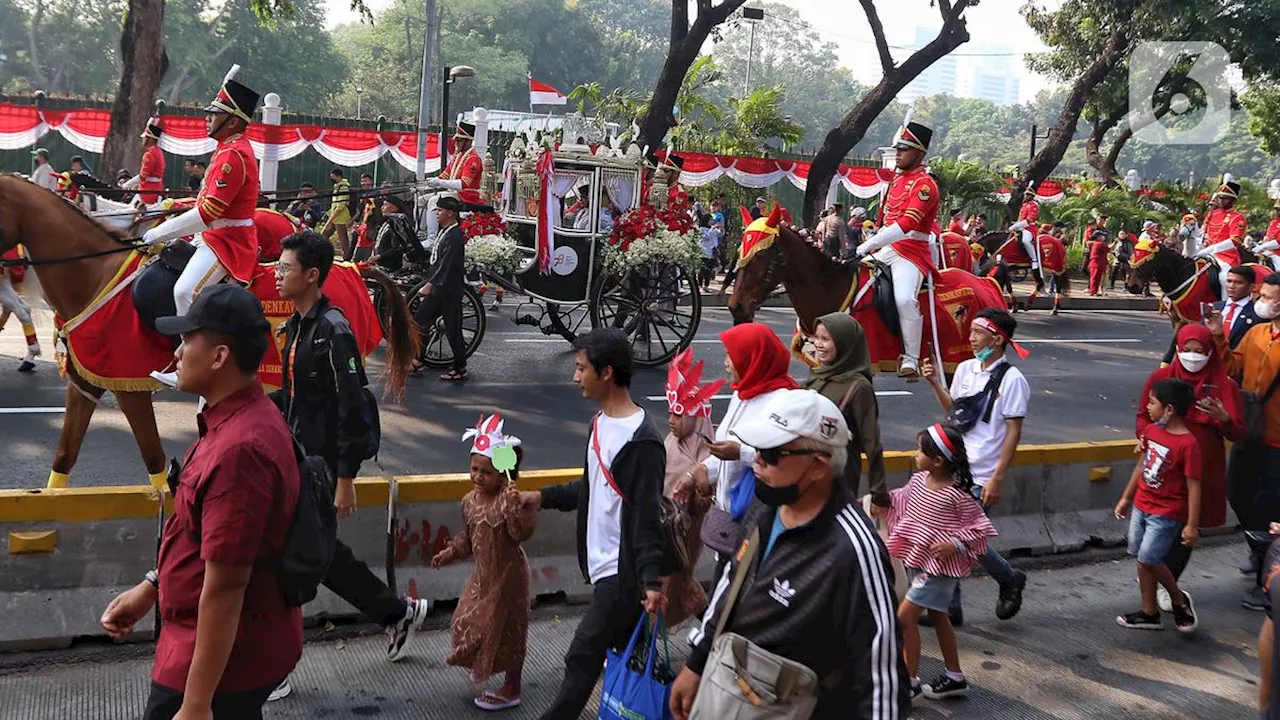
top-left (186, 430), bottom-right (338, 607)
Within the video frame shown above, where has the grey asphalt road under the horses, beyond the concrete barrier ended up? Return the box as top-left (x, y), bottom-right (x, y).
top-left (0, 301), bottom-right (1171, 488)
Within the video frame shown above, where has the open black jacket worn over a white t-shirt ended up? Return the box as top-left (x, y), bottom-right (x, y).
top-left (541, 414), bottom-right (667, 597)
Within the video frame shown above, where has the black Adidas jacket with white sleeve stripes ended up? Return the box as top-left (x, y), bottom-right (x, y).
top-left (689, 480), bottom-right (910, 720)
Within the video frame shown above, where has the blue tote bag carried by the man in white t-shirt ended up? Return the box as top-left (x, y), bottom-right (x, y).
top-left (598, 614), bottom-right (675, 720)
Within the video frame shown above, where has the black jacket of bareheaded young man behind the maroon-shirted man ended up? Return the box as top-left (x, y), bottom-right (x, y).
top-left (271, 296), bottom-right (371, 478)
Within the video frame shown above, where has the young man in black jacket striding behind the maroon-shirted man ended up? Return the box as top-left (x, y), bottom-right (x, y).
top-left (271, 231), bottom-right (429, 681)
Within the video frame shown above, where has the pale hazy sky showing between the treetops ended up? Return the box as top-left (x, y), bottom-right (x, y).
top-left (326, 0), bottom-right (1060, 101)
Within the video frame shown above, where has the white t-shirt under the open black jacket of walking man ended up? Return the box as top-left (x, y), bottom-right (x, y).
top-left (586, 410), bottom-right (644, 583)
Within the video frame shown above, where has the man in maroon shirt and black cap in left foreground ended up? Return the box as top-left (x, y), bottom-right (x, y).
top-left (102, 284), bottom-right (302, 720)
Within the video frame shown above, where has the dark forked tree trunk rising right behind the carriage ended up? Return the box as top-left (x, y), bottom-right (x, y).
top-left (639, 0), bottom-right (746, 158)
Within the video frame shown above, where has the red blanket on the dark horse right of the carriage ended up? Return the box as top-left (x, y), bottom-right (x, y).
top-left (849, 265), bottom-right (1005, 372)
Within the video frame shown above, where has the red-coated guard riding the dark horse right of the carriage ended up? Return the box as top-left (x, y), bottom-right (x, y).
top-left (858, 116), bottom-right (940, 378)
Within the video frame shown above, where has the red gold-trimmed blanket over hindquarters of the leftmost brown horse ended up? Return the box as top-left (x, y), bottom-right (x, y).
top-left (248, 261), bottom-right (383, 388)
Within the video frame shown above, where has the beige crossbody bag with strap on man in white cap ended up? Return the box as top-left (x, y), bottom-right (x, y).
top-left (689, 520), bottom-right (819, 720)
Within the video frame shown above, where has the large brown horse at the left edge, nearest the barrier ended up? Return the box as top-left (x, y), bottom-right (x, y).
top-left (0, 176), bottom-right (419, 487)
